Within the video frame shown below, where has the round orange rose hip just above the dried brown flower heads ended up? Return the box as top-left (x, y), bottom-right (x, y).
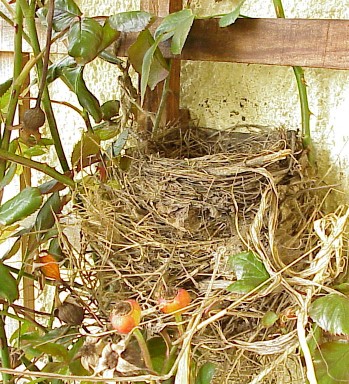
top-left (110, 299), bottom-right (141, 334)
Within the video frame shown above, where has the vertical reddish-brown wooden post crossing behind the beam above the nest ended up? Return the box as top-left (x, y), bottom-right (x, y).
top-left (141, 0), bottom-right (183, 129)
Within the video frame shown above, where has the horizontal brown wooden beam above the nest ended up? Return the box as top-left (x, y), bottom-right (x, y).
top-left (119, 19), bottom-right (349, 69)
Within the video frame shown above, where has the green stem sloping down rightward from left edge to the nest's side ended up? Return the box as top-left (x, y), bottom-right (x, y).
top-left (0, 149), bottom-right (75, 189)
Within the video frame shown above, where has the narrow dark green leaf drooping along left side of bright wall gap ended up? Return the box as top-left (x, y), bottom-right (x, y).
top-left (63, 67), bottom-right (102, 123)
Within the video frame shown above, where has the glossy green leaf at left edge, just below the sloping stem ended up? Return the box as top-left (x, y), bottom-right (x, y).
top-left (0, 187), bottom-right (42, 225)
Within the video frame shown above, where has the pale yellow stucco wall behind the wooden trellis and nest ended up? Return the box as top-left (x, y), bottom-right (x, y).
top-left (75, 0), bottom-right (349, 210)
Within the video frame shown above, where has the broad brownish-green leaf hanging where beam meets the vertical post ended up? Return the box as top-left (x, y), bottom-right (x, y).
top-left (128, 29), bottom-right (169, 102)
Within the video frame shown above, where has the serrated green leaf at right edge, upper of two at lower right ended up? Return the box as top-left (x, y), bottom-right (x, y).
top-left (309, 293), bottom-right (349, 335)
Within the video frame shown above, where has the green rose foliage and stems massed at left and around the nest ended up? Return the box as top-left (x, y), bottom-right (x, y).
top-left (0, 0), bottom-right (316, 384)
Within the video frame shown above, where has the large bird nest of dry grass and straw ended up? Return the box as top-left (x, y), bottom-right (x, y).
top-left (66, 127), bottom-right (344, 383)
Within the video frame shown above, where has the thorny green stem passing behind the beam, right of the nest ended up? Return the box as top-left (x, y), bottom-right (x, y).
top-left (273, 0), bottom-right (315, 165)
